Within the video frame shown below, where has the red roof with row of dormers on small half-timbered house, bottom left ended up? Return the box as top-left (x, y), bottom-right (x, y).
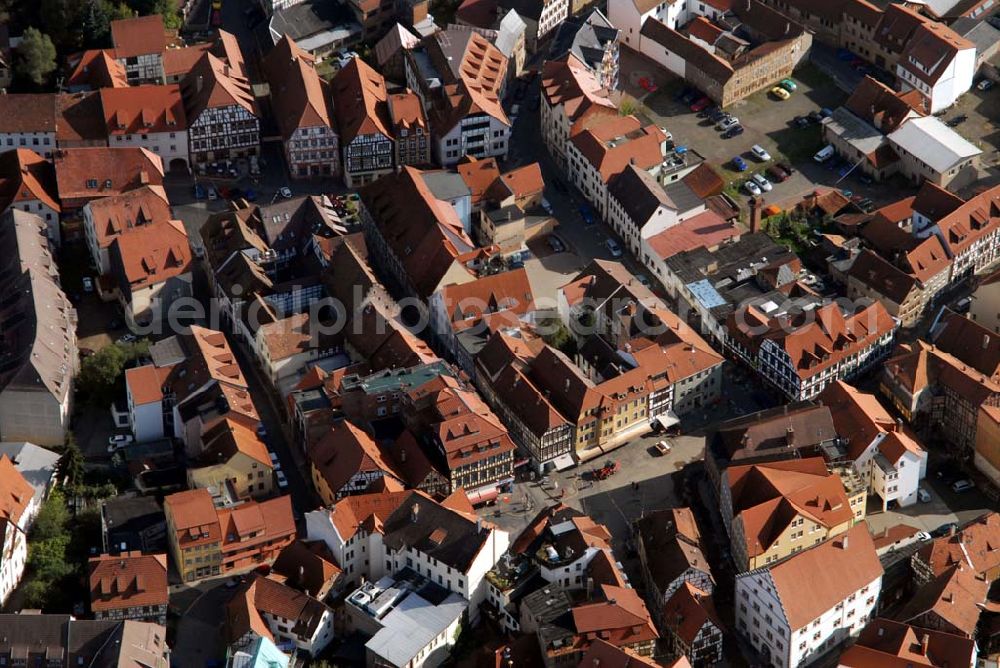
top-left (88, 552), bottom-right (168, 612)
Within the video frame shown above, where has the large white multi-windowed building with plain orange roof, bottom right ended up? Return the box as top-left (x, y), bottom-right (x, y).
top-left (735, 522), bottom-right (882, 668)
